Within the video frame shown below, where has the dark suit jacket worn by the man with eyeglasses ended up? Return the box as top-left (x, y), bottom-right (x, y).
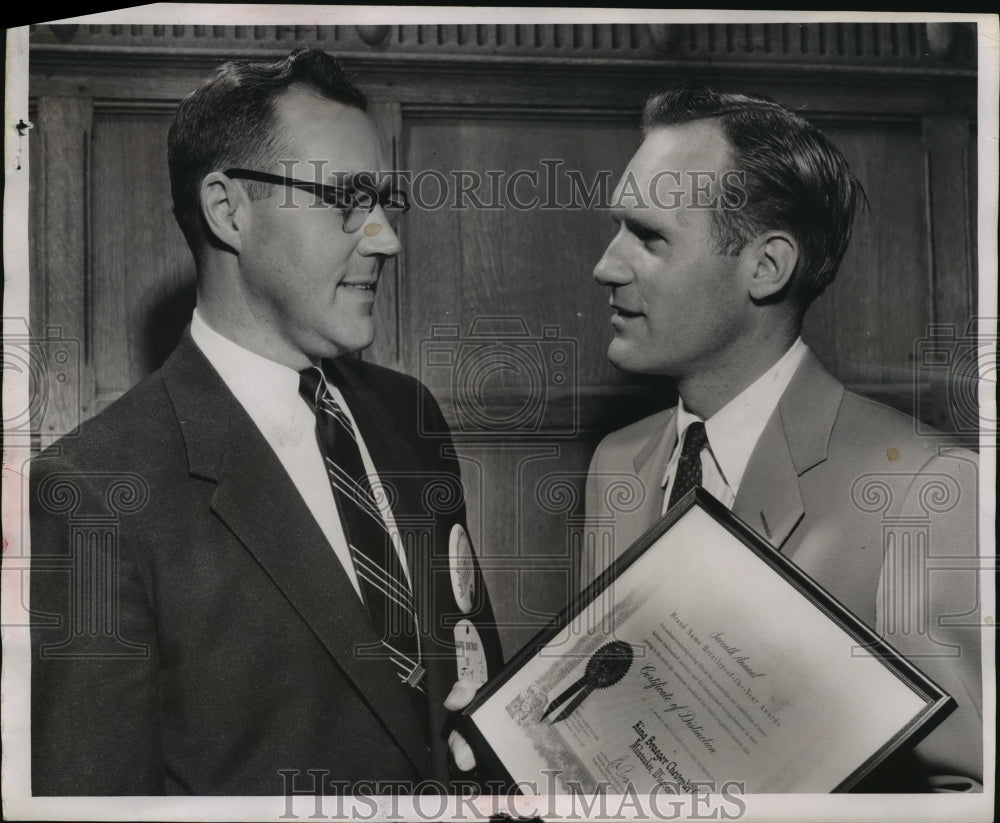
top-left (31, 334), bottom-right (502, 795)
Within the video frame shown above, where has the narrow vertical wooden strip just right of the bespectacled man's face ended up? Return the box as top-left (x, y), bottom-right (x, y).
top-left (362, 102), bottom-right (409, 369)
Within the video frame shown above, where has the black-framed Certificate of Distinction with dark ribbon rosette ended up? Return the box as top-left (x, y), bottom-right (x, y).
top-left (466, 489), bottom-right (955, 794)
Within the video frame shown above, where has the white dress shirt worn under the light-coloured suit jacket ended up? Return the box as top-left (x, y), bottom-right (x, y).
top-left (661, 337), bottom-right (809, 513)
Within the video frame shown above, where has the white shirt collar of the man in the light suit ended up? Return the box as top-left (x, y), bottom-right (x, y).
top-left (664, 337), bottom-right (809, 495)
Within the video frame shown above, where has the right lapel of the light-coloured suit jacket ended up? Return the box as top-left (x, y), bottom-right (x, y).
top-left (733, 351), bottom-right (844, 549)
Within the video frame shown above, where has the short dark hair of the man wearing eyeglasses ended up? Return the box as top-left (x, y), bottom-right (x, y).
top-left (167, 49), bottom-right (368, 248)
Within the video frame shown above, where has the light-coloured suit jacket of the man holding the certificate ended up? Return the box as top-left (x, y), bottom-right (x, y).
top-left (584, 353), bottom-right (983, 790)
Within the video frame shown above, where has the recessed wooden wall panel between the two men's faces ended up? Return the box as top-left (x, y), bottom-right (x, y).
top-left (401, 119), bottom-right (672, 428)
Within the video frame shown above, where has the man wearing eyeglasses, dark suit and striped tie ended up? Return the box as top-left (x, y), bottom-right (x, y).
top-left (31, 50), bottom-right (501, 795)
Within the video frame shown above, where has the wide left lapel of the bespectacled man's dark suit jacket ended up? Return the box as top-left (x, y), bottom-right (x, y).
top-left (162, 334), bottom-right (427, 772)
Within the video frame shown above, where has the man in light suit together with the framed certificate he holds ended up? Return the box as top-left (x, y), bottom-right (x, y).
top-left (467, 87), bottom-right (983, 797)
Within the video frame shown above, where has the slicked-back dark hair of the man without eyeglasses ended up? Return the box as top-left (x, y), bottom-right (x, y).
top-left (642, 86), bottom-right (867, 310)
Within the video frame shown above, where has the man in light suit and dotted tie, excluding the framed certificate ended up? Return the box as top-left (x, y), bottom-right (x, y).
top-left (584, 88), bottom-right (983, 791)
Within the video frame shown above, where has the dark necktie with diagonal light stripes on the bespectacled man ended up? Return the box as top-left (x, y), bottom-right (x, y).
top-left (299, 366), bottom-right (424, 692)
